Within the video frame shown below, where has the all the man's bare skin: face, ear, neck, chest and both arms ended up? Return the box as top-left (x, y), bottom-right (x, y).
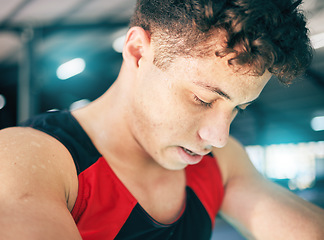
top-left (0, 27), bottom-right (324, 240)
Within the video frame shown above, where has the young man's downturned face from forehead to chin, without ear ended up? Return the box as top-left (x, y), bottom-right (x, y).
top-left (130, 49), bottom-right (271, 170)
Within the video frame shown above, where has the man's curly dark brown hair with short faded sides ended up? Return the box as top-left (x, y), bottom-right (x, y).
top-left (130, 0), bottom-right (313, 82)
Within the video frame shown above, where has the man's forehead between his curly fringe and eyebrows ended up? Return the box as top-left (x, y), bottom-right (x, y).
top-left (167, 55), bottom-right (271, 100)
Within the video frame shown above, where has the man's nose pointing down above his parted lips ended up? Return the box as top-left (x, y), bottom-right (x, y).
top-left (198, 109), bottom-right (232, 148)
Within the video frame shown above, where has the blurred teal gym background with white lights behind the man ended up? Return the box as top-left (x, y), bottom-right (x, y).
top-left (0, 0), bottom-right (324, 240)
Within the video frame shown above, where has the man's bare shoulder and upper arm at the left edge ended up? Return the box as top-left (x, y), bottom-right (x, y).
top-left (0, 128), bottom-right (80, 239)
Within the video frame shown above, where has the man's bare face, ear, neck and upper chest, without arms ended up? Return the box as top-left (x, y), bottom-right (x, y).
top-left (73, 27), bottom-right (271, 223)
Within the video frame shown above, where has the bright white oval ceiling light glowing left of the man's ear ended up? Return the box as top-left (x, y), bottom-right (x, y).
top-left (56, 58), bottom-right (86, 80)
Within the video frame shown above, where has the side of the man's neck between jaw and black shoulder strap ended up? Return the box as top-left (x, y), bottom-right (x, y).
top-left (72, 64), bottom-right (161, 172)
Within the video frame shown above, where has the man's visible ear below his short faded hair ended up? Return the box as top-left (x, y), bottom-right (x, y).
top-left (123, 27), bottom-right (151, 67)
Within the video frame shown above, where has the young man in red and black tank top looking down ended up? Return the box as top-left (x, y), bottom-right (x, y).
top-left (0, 0), bottom-right (324, 240)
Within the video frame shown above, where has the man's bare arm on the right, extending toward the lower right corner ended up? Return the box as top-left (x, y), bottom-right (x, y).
top-left (213, 139), bottom-right (324, 239)
